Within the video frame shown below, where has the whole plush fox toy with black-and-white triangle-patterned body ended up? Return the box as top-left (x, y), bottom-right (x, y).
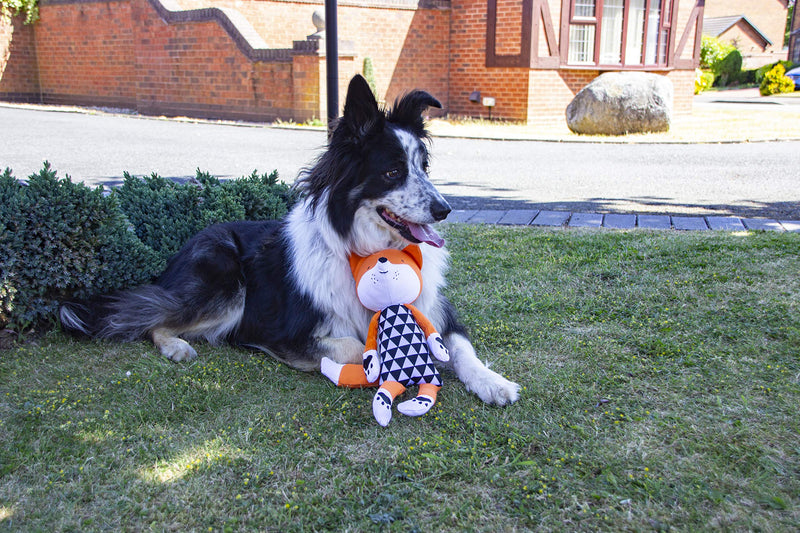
top-left (322, 244), bottom-right (450, 426)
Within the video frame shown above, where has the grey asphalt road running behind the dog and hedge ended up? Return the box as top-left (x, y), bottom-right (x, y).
top-left (0, 106), bottom-right (800, 220)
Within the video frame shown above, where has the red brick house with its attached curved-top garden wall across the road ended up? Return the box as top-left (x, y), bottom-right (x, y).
top-left (0, 0), bottom-right (700, 123)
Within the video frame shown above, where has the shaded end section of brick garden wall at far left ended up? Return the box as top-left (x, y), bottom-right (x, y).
top-left (0, 17), bottom-right (40, 102)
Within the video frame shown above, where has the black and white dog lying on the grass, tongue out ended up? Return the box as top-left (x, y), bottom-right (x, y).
top-left (60, 76), bottom-right (519, 405)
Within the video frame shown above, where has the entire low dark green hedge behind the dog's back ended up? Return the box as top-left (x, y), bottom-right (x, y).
top-left (0, 163), bottom-right (295, 331)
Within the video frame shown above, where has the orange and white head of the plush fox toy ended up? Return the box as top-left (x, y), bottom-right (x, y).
top-left (350, 244), bottom-right (422, 311)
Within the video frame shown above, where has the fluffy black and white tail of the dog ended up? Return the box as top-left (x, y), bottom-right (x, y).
top-left (59, 285), bottom-right (180, 341)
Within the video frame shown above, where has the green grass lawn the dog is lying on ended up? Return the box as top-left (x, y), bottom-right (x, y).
top-left (0, 226), bottom-right (800, 531)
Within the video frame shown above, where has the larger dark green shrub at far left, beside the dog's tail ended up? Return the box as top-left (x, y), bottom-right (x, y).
top-left (0, 163), bottom-right (164, 330)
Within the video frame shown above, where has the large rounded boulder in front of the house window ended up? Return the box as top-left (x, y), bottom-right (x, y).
top-left (567, 72), bottom-right (674, 135)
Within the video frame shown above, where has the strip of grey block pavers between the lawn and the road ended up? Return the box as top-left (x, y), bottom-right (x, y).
top-left (447, 209), bottom-right (800, 233)
